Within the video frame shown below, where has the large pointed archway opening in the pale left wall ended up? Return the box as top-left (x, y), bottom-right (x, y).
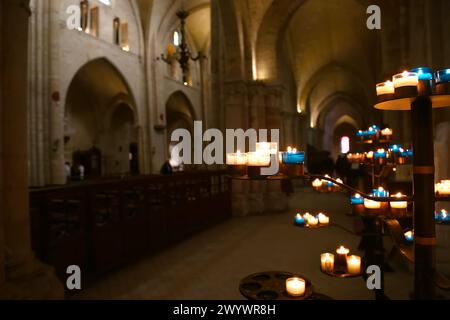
top-left (65, 58), bottom-right (139, 179)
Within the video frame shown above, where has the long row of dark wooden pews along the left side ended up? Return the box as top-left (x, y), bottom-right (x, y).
top-left (30, 171), bottom-right (231, 280)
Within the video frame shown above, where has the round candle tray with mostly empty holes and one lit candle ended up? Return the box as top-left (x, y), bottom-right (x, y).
top-left (239, 271), bottom-right (313, 300)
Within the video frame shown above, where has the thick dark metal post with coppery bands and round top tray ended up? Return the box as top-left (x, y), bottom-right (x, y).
top-left (375, 82), bottom-right (450, 299)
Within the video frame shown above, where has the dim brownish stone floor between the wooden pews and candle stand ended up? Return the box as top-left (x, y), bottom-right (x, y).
top-left (73, 189), bottom-right (442, 300)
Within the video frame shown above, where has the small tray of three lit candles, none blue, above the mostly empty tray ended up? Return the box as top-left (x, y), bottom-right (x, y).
top-left (320, 246), bottom-right (363, 279)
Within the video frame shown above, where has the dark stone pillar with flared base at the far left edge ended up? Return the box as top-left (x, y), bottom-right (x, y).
top-left (0, 0), bottom-right (64, 299)
